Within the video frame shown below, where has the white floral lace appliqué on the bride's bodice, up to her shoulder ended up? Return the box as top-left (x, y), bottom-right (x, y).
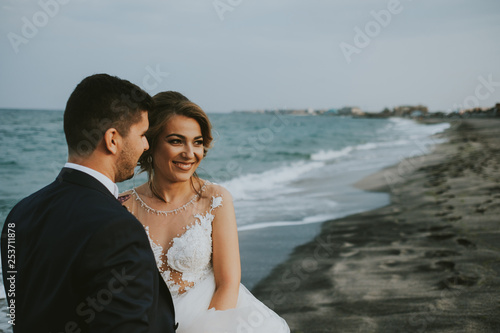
top-left (144, 196), bottom-right (222, 297)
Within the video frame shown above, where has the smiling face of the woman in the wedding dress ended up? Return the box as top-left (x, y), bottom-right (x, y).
top-left (153, 115), bottom-right (203, 182)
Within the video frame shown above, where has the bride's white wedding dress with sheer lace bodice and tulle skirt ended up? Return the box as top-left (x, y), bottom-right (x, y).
top-left (122, 182), bottom-right (290, 333)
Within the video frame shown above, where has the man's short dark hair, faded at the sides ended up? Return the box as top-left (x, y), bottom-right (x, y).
top-left (64, 74), bottom-right (153, 156)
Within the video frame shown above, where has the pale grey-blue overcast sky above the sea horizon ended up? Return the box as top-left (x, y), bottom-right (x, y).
top-left (0, 0), bottom-right (500, 112)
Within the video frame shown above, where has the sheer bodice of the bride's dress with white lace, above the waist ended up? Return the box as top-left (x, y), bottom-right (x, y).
top-left (122, 185), bottom-right (222, 297)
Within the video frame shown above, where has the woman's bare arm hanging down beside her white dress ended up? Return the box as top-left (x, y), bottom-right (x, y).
top-left (209, 189), bottom-right (241, 310)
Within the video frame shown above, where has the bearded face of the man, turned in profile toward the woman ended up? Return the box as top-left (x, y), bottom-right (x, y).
top-left (115, 111), bottom-right (149, 183)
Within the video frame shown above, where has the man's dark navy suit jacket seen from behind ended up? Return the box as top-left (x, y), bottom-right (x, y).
top-left (1, 168), bottom-right (175, 333)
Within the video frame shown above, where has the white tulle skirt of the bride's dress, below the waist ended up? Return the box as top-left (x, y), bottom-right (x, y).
top-left (174, 274), bottom-right (290, 333)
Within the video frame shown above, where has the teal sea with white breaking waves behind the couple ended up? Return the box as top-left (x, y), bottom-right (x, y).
top-left (0, 109), bottom-right (449, 332)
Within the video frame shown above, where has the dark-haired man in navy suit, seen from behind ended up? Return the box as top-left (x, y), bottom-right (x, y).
top-left (1, 74), bottom-right (175, 333)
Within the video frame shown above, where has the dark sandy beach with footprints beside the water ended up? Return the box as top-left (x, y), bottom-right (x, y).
top-left (253, 119), bottom-right (500, 333)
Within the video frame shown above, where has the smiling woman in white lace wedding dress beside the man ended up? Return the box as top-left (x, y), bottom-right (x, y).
top-left (120, 91), bottom-right (290, 333)
